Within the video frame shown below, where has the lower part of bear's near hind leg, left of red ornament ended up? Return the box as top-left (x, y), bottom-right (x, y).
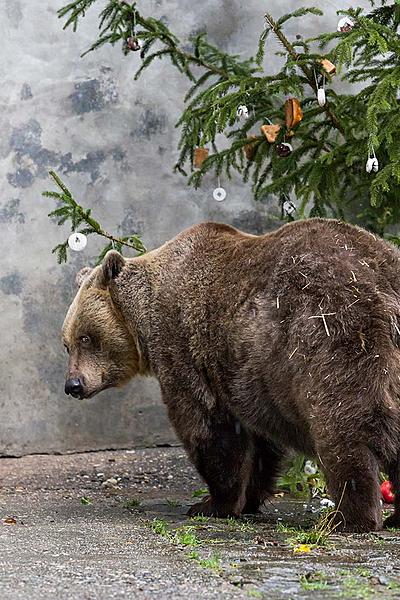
top-left (318, 440), bottom-right (382, 533)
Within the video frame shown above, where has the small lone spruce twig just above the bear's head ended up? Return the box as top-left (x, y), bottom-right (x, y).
top-left (42, 171), bottom-right (146, 263)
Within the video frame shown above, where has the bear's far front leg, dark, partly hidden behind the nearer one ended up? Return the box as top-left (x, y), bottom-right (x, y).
top-left (243, 435), bottom-right (284, 514)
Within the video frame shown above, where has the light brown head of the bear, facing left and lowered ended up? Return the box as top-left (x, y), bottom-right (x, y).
top-left (62, 251), bottom-right (141, 398)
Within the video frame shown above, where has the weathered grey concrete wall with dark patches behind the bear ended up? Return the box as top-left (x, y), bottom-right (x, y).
top-left (0, 0), bottom-right (362, 454)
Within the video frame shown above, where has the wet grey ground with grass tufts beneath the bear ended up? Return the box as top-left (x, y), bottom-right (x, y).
top-left (0, 448), bottom-right (400, 600)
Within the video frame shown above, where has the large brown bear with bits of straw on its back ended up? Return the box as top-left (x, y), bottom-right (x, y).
top-left (63, 219), bottom-right (400, 532)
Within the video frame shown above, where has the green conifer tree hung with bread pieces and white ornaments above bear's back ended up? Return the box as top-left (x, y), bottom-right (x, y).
top-left (47, 0), bottom-right (400, 260)
